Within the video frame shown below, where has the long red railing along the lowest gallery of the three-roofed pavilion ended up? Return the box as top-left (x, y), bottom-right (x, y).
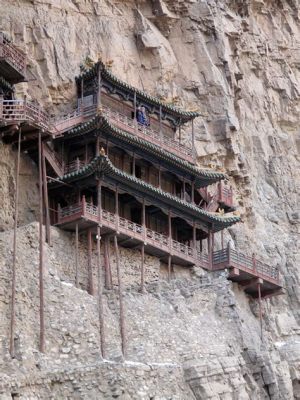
top-left (58, 198), bottom-right (209, 269)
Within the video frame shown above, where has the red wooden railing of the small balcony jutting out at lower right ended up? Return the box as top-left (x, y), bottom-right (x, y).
top-left (212, 248), bottom-right (279, 283)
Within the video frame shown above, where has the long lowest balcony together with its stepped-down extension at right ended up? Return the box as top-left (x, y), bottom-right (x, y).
top-left (56, 202), bottom-right (282, 297)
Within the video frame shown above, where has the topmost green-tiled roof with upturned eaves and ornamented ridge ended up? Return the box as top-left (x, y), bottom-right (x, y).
top-left (76, 61), bottom-right (199, 126)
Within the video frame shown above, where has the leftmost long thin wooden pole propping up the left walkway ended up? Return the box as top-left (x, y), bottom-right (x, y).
top-left (9, 128), bottom-right (21, 358)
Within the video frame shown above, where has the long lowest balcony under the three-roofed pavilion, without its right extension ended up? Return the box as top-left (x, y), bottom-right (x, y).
top-left (56, 200), bottom-right (209, 269)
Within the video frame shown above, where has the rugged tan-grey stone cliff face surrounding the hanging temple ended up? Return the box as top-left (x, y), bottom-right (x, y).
top-left (0, 0), bottom-right (300, 400)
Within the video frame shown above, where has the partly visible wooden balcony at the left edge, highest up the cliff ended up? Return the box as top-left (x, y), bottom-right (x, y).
top-left (0, 33), bottom-right (26, 84)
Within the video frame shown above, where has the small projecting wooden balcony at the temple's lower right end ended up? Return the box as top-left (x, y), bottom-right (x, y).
top-left (212, 248), bottom-right (282, 297)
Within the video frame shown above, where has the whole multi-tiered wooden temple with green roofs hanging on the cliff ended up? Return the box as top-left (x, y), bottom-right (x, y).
top-left (0, 35), bottom-right (281, 354)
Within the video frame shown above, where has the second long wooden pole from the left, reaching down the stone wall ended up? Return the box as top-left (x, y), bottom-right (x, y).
top-left (38, 131), bottom-right (45, 353)
